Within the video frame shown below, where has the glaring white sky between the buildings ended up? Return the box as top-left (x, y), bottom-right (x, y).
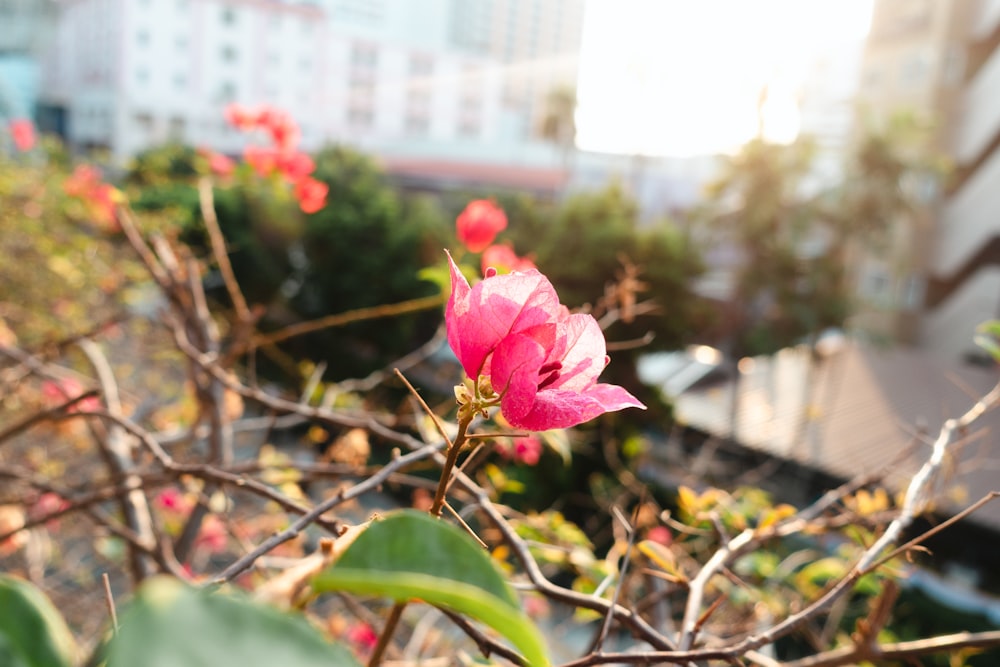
top-left (577, 0), bottom-right (872, 156)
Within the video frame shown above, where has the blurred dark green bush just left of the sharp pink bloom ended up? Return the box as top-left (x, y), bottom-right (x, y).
top-left (289, 148), bottom-right (449, 378)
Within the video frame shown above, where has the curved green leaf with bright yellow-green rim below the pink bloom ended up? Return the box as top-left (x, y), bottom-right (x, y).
top-left (313, 510), bottom-right (549, 667)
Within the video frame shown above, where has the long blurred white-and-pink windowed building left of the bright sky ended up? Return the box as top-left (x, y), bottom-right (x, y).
top-left (43, 0), bottom-right (583, 177)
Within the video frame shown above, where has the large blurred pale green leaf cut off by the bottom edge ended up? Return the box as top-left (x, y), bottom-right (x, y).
top-left (105, 578), bottom-right (358, 667)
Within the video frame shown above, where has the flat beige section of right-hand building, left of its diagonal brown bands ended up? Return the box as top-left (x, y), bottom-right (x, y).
top-left (853, 0), bottom-right (976, 344)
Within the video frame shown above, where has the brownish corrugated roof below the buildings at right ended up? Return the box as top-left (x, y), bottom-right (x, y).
top-left (676, 344), bottom-right (1000, 528)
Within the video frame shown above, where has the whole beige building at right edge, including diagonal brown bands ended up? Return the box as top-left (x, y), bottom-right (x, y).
top-left (857, 0), bottom-right (1000, 361)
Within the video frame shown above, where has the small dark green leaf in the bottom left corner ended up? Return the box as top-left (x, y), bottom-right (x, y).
top-left (0, 574), bottom-right (77, 667)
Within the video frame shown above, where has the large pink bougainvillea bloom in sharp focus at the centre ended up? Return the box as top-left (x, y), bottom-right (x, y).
top-left (445, 255), bottom-right (646, 431)
